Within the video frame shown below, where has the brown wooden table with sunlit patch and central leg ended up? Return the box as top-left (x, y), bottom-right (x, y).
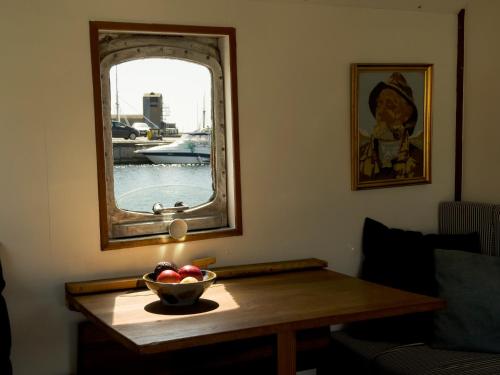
top-left (67, 269), bottom-right (444, 374)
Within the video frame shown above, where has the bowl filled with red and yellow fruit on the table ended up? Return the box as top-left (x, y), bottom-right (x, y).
top-left (142, 262), bottom-right (217, 306)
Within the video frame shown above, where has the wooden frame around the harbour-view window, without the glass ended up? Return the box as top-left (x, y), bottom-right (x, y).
top-left (89, 21), bottom-right (242, 250)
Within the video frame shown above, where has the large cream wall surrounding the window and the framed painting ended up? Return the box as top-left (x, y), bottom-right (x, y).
top-left (0, 0), bottom-right (458, 375)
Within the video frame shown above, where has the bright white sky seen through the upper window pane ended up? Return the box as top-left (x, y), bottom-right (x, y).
top-left (110, 58), bottom-right (212, 132)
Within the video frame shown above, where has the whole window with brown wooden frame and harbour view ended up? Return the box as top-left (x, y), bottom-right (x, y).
top-left (90, 22), bottom-right (241, 249)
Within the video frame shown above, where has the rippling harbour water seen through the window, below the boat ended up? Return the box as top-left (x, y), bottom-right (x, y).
top-left (113, 164), bottom-right (213, 213)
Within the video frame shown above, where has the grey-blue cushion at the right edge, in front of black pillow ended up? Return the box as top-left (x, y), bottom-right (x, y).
top-left (432, 250), bottom-right (500, 353)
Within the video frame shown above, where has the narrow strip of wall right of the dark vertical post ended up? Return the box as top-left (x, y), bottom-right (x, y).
top-left (462, 0), bottom-right (500, 203)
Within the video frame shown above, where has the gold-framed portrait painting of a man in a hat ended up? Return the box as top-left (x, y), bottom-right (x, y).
top-left (351, 64), bottom-right (432, 190)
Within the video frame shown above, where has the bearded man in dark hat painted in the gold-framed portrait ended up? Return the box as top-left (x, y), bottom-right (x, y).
top-left (359, 72), bottom-right (423, 181)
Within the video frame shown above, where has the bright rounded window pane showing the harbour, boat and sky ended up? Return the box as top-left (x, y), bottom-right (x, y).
top-left (109, 58), bottom-right (214, 212)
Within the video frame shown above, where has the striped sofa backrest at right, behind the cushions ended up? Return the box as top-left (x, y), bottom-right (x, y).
top-left (438, 202), bottom-right (500, 256)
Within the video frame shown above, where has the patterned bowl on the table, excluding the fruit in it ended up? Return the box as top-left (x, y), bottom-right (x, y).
top-left (142, 270), bottom-right (217, 306)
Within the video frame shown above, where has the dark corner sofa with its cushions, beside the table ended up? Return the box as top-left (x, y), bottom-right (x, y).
top-left (331, 202), bottom-right (500, 375)
